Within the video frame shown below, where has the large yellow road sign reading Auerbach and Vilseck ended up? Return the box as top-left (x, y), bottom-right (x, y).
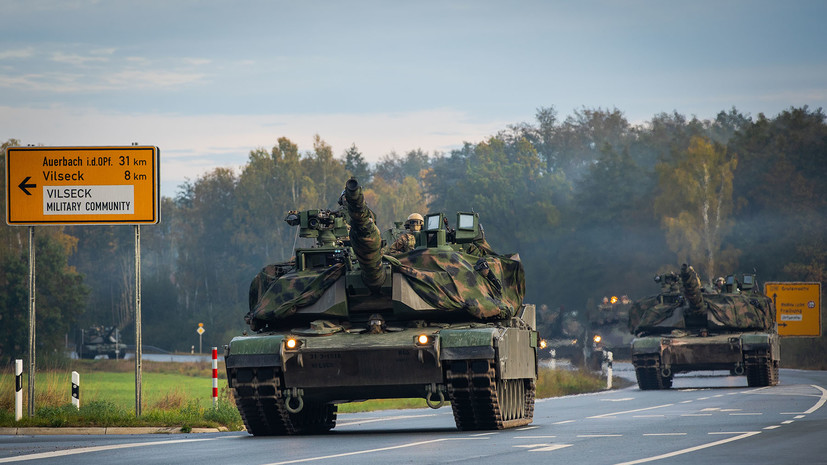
top-left (6, 146), bottom-right (161, 225)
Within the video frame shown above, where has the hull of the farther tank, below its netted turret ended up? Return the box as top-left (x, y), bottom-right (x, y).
top-left (631, 332), bottom-right (780, 389)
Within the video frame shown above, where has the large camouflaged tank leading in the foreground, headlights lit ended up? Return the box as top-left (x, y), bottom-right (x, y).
top-left (225, 179), bottom-right (538, 436)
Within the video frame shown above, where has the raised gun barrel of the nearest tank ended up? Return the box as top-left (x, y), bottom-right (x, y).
top-left (344, 178), bottom-right (385, 289)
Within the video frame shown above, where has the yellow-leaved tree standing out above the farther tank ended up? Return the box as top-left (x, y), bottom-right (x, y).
top-left (655, 137), bottom-right (738, 280)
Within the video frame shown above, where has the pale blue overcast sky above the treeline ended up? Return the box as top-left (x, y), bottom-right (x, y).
top-left (0, 0), bottom-right (827, 196)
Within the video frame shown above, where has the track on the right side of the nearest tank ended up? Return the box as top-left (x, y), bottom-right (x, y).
top-left (446, 360), bottom-right (537, 431)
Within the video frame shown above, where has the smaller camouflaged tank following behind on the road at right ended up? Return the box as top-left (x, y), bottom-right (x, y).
top-left (629, 265), bottom-right (780, 389)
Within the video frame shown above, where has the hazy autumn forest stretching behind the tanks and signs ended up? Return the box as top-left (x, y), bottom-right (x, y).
top-left (0, 106), bottom-right (827, 368)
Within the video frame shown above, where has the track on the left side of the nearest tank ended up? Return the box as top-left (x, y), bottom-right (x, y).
top-left (233, 367), bottom-right (337, 436)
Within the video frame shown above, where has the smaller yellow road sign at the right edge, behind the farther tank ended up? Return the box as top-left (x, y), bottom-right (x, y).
top-left (764, 282), bottom-right (821, 337)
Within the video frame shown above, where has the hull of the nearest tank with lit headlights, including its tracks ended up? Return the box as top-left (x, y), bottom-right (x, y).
top-left (225, 320), bottom-right (537, 435)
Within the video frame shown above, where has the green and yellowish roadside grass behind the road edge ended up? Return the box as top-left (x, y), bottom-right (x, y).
top-left (0, 360), bottom-right (632, 432)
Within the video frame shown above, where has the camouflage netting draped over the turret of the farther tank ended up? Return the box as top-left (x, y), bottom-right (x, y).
top-left (629, 294), bottom-right (775, 334)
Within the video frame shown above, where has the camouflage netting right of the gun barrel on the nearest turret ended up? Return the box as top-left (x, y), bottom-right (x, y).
top-left (386, 249), bottom-right (525, 319)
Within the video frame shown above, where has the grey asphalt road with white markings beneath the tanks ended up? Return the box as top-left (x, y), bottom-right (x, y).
top-left (0, 366), bottom-right (827, 465)
